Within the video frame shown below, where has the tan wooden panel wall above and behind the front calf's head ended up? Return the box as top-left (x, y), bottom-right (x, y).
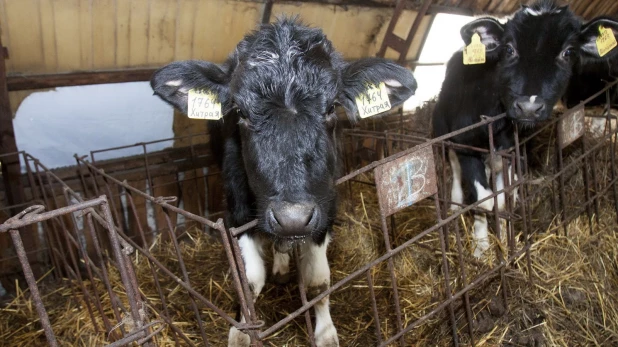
top-left (0, 0), bottom-right (429, 115)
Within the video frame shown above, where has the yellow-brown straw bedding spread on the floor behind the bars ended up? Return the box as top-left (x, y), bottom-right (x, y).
top-left (0, 174), bottom-right (618, 346)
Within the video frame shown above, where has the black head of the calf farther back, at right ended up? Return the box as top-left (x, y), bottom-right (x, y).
top-left (461, 0), bottom-right (618, 124)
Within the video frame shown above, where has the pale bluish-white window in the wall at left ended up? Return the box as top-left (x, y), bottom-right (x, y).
top-left (13, 82), bottom-right (174, 168)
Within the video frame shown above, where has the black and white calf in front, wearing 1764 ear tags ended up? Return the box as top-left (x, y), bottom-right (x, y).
top-left (151, 19), bottom-right (416, 346)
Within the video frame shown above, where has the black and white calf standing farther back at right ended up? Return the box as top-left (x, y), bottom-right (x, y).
top-left (432, 1), bottom-right (618, 257)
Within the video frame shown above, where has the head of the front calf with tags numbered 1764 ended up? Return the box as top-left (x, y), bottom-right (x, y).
top-left (151, 19), bottom-right (416, 238)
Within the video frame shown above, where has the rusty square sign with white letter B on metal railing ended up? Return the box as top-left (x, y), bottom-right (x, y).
top-left (375, 146), bottom-right (438, 216)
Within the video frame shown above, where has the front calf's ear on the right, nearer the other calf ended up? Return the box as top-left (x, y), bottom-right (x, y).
top-left (338, 58), bottom-right (416, 121)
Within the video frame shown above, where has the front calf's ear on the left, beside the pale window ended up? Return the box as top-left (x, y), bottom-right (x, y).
top-left (150, 60), bottom-right (228, 114)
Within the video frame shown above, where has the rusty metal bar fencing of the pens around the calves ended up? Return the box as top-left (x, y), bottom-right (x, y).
top-left (0, 81), bottom-right (618, 346)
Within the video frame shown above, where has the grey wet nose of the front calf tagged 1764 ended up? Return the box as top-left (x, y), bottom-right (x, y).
top-left (270, 202), bottom-right (316, 237)
